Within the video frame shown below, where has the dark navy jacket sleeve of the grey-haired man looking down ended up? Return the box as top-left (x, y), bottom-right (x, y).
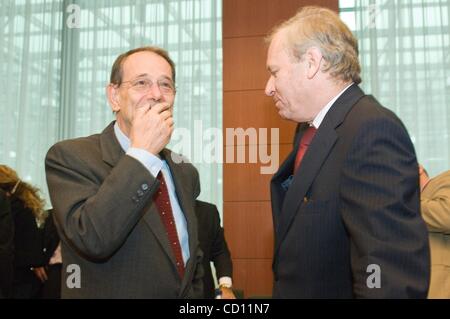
top-left (340, 118), bottom-right (430, 298)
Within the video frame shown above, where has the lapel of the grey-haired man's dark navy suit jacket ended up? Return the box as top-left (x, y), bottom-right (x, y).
top-left (275, 85), bottom-right (364, 252)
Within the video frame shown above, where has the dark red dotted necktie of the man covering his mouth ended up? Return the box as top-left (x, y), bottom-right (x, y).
top-left (153, 172), bottom-right (184, 278)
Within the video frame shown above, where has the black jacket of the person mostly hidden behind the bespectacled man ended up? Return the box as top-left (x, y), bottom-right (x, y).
top-left (195, 200), bottom-right (233, 298)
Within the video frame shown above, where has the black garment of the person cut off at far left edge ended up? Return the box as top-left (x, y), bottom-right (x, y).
top-left (0, 189), bottom-right (14, 298)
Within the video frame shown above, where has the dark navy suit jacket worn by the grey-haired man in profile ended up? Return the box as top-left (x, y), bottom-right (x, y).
top-left (271, 85), bottom-right (430, 298)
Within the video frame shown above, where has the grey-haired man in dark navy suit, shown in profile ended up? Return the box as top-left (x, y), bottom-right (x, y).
top-left (266, 7), bottom-right (430, 298)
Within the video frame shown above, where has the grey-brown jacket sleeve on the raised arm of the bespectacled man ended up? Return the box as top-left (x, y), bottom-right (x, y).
top-left (45, 142), bottom-right (159, 261)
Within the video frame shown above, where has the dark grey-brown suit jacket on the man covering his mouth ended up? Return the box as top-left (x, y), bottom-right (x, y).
top-left (46, 122), bottom-right (203, 298)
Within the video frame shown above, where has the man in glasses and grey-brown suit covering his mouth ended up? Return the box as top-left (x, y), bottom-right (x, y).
top-left (46, 47), bottom-right (203, 298)
